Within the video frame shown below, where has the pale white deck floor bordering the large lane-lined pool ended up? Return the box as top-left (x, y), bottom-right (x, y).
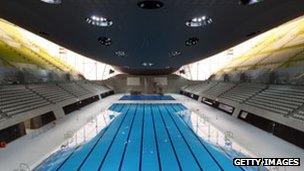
top-left (0, 94), bottom-right (304, 171)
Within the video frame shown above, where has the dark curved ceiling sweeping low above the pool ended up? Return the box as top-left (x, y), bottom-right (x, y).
top-left (0, 0), bottom-right (304, 74)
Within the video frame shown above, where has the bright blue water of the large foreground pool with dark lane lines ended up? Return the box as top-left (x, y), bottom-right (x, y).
top-left (36, 103), bottom-right (254, 171)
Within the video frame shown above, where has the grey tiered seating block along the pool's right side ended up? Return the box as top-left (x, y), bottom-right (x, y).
top-left (181, 82), bottom-right (304, 123)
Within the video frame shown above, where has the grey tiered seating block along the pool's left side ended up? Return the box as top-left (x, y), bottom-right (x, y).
top-left (0, 82), bottom-right (111, 121)
